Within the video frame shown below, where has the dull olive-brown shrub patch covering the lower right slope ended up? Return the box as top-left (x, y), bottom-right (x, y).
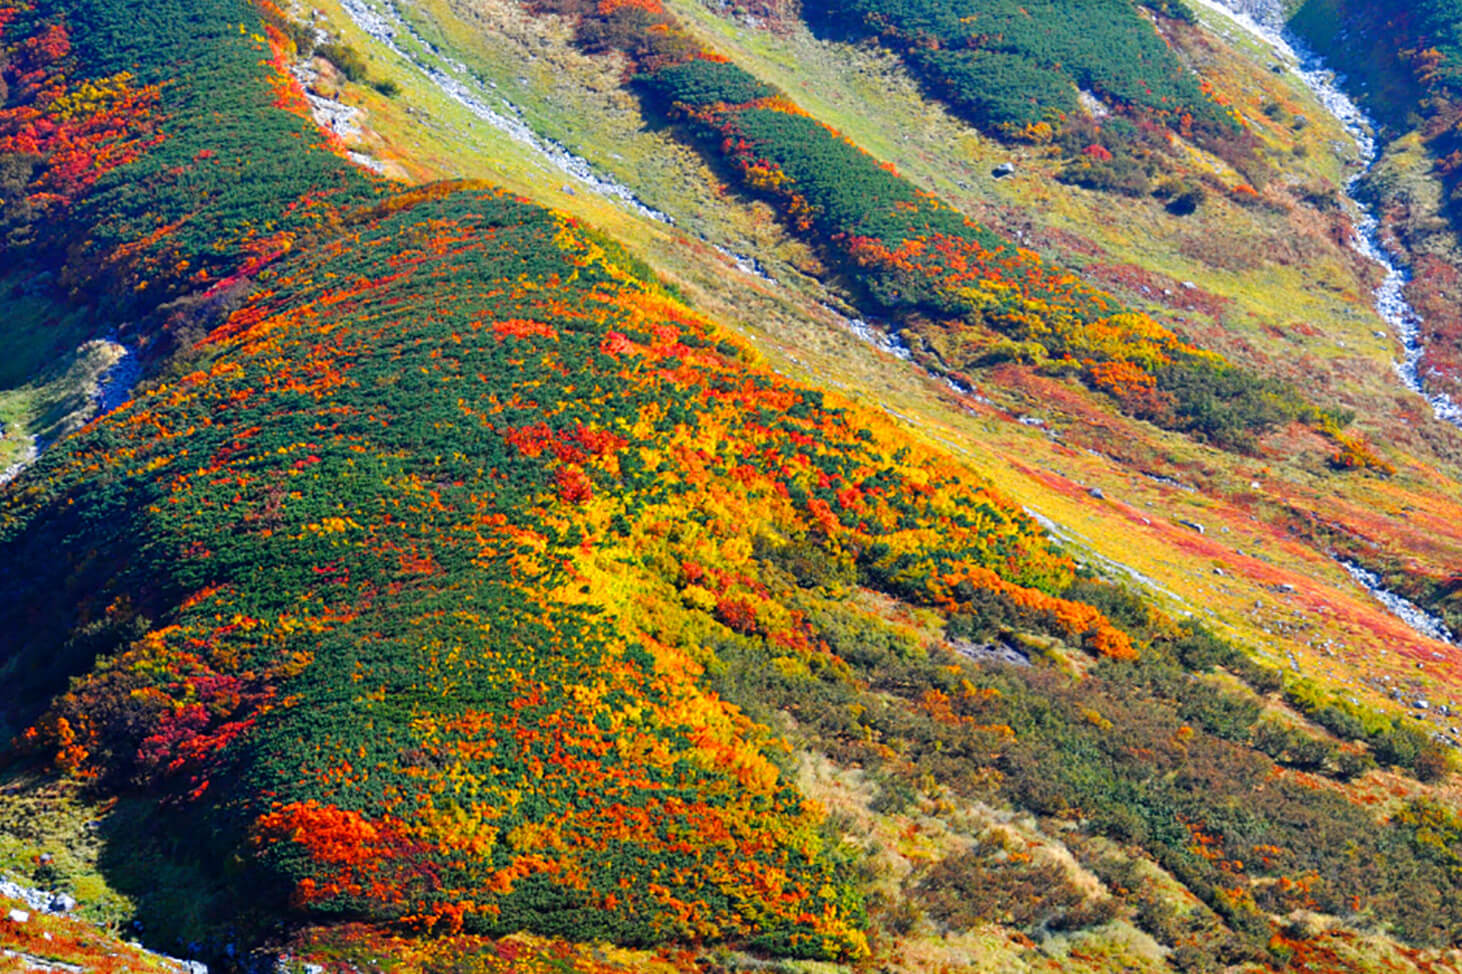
top-left (718, 582), bottom-right (1462, 970)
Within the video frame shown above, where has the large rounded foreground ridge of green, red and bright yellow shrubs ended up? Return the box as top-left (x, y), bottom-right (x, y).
top-left (3, 4), bottom-right (1130, 955)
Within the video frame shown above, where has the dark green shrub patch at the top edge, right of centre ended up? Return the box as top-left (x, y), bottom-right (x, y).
top-left (806, 0), bottom-right (1251, 187)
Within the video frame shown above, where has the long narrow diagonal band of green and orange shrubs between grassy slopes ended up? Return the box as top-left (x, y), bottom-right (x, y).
top-left (550, 1), bottom-right (1311, 446)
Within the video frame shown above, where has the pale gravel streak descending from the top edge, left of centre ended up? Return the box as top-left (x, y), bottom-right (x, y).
top-left (341, 0), bottom-right (675, 224)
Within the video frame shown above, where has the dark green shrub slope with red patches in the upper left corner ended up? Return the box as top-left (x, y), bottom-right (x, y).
top-left (0, 0), bottom-right (376, 352)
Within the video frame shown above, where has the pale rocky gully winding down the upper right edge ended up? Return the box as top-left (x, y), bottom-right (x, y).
top-left (1193, 0), bottom-right (1462, 427)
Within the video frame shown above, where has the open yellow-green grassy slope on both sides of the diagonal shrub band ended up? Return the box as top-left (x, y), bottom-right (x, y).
top-left (302, 3), bottom-right (1462, 727)
